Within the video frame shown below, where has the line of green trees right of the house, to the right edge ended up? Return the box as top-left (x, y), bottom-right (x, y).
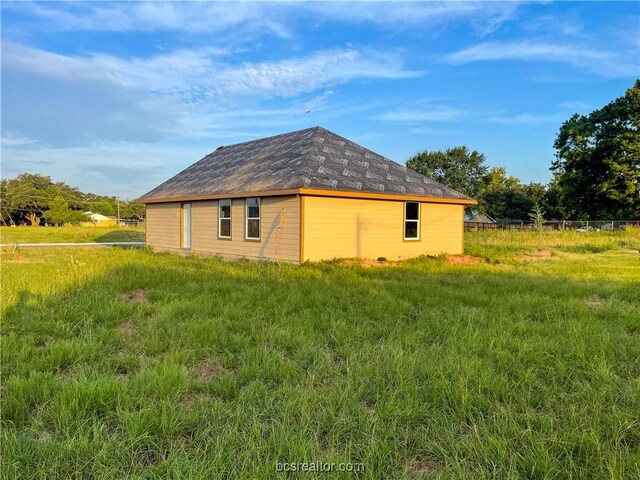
top-left (407, 80), bottom-right (640, 220)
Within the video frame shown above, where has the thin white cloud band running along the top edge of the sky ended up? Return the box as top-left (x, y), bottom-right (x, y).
top-left (3, 1), bottom-right (520, 37)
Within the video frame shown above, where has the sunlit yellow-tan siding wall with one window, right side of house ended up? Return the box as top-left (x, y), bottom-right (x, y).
top-left (303, 196), bottom-right (464, 260)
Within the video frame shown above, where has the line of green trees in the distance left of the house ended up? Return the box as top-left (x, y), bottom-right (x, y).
top-left (0, 173), bottom-right (145, 226)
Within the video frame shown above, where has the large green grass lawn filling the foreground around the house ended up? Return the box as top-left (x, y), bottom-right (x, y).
top-left (1, 230), bottom-right (640, 479)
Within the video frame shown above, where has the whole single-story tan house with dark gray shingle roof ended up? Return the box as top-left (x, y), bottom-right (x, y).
top-left (138, 127), bottom-right (476, 263)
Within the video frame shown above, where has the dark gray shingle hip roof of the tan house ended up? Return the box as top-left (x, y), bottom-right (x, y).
top-left (139, 127), bottom-right (469, 203)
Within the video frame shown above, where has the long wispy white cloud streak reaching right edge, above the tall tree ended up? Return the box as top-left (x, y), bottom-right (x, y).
top-left (445, 41), bottom-right (640, 76)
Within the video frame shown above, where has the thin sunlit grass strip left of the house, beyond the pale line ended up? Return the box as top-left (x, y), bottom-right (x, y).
top-left (0, 226), bottom-right (144, 243)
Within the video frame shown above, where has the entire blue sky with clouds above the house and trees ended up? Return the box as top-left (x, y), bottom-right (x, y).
top-left (0, 1), bottom-right (640, 198)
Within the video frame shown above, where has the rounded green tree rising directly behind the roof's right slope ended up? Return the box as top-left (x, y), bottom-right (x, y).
top-left (407, 146), bottom-right (487, 198)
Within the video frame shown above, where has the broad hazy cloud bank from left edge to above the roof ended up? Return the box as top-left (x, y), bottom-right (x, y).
top-left (2, 42), bottom-right (421, 146)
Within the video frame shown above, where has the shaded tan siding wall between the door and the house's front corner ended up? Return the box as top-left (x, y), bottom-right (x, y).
top-left (191, 196), bottom-right (300, 262)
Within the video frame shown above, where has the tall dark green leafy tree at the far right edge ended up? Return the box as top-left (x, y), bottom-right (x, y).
top-left (551, 80), bottom-right (640, 219)
